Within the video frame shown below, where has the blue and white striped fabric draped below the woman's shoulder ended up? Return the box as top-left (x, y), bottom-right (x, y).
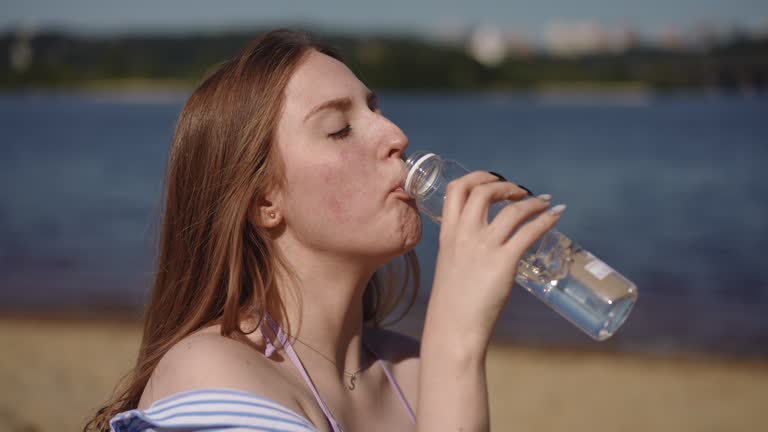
top-left (109, 389), bottom-right (317, 432)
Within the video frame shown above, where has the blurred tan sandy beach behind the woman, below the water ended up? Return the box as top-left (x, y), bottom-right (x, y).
top-left (0, 318), bottom-right (768, 432)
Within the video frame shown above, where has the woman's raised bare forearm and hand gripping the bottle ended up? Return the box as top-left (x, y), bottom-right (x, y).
top-left (417, 172), bottom-right (559, 432)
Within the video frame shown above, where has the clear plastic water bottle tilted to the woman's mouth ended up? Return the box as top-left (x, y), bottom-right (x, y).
top-left (405, 152), bottom-right (637, 341)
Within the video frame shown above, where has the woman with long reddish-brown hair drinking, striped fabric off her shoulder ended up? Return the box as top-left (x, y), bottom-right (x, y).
top-left (86, 30), bottom-right (562, 431)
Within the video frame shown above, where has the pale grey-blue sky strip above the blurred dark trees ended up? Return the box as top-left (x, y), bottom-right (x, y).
top-left (0, 0), bottom-right (768, 34)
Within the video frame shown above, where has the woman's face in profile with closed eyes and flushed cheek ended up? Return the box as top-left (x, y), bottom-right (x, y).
top-left (277, 51), bottom-right (421, 262)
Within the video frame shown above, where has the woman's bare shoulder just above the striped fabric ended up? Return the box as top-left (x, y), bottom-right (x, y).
top-left (139, 330), bottom-right (303, 413)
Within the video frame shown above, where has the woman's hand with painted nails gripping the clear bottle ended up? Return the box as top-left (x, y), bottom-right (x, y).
top-left (427, 171), bottom-right (560, 350)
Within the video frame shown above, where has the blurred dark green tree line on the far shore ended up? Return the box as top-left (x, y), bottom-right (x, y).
top-left (0, 31), bottom-right (768, 90)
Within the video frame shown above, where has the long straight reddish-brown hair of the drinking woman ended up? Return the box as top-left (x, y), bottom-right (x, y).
top-left (83, 30), bottom-right (419, 431)
